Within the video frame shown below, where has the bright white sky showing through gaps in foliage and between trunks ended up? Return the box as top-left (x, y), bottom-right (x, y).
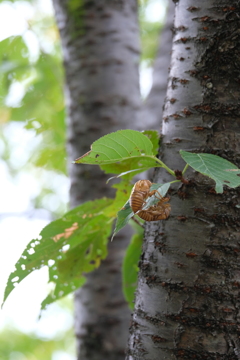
top-left (0, 0), bottom-right (166, 360)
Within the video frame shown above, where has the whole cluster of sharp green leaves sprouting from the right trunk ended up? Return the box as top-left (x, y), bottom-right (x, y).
top-left (4, 130), bottom-right (240, 309)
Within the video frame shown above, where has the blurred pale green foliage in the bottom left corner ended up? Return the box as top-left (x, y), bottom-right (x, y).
top-left (0, 296), bottom-right (76, 360)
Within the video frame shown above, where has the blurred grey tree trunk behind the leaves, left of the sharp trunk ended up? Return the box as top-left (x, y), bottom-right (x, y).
top-left (53, 0), bottom-right (141, 360)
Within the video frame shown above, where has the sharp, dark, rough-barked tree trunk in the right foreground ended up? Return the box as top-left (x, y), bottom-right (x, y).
top-left (127, 0), bottom-right (240, 360)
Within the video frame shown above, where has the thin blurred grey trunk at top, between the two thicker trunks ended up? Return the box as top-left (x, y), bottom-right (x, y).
top-left (139, 0), bottom-right (175, 130)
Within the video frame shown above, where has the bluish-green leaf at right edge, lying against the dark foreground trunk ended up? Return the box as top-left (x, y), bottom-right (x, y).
top-left (180, 150), bottom-right (240, 193)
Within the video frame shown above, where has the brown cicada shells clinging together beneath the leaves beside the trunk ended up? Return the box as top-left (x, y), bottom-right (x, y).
top-left (130, 180), bottom-right (171, 221)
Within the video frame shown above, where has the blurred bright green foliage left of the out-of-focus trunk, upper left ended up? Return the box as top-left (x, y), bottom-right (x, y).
top-left (0, 1), bottom-right (67, 217)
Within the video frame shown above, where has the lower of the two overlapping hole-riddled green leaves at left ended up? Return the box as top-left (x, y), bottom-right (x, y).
top-left (42, 215), bottom-right (111, 308)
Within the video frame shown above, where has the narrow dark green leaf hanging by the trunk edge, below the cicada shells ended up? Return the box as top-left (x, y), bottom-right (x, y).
top-left (122, 233), bottom-right (143, 309)
